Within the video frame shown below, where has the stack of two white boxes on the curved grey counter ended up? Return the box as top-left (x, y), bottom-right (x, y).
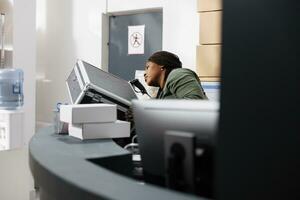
top-left (60, 104), bottom-right (130, 140)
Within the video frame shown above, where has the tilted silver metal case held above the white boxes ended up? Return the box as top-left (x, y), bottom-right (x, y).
top-left (66, 60), bottom-right (137, 120)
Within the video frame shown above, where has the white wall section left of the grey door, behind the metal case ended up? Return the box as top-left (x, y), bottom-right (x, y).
top-left (37, 0), bottom-right (105, 125)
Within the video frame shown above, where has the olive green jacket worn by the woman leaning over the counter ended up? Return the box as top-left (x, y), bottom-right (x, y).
top-left (157, 68), bottom-right (207, 99)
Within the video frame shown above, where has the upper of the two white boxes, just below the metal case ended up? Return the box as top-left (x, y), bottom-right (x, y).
top-left (60, 103), bottom-right (117, 124)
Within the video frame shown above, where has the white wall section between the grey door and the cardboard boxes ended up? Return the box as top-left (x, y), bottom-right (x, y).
top-left (163, 0), bottom-right (199, 70)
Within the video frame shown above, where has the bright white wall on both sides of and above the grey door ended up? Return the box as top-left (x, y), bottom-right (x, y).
top-left (37, 0), bottom-right (199, 122)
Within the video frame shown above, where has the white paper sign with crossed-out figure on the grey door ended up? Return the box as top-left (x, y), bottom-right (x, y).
top-left (128, 25), bottom-right (145, 55)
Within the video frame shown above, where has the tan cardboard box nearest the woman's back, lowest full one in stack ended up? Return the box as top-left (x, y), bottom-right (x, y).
top-left (196, 45), bottom-right (221, 77)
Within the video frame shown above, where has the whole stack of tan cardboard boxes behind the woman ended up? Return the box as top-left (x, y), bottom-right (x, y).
top-left (196, 0), bottom-right (222, 81)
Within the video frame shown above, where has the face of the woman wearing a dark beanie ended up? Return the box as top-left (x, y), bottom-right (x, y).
top-left (144, 61), bottom-right (163, 87)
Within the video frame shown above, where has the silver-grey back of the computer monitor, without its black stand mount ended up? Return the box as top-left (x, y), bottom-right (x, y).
top-left (132, 100), bottom-right (219, 192)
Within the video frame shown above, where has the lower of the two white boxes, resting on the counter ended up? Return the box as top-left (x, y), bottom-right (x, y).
top-left (69, 120), bottom-right (130, 140)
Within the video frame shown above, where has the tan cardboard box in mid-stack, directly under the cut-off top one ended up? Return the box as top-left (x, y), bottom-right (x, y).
top-left (199, 11), bottom-right (222, 44)
